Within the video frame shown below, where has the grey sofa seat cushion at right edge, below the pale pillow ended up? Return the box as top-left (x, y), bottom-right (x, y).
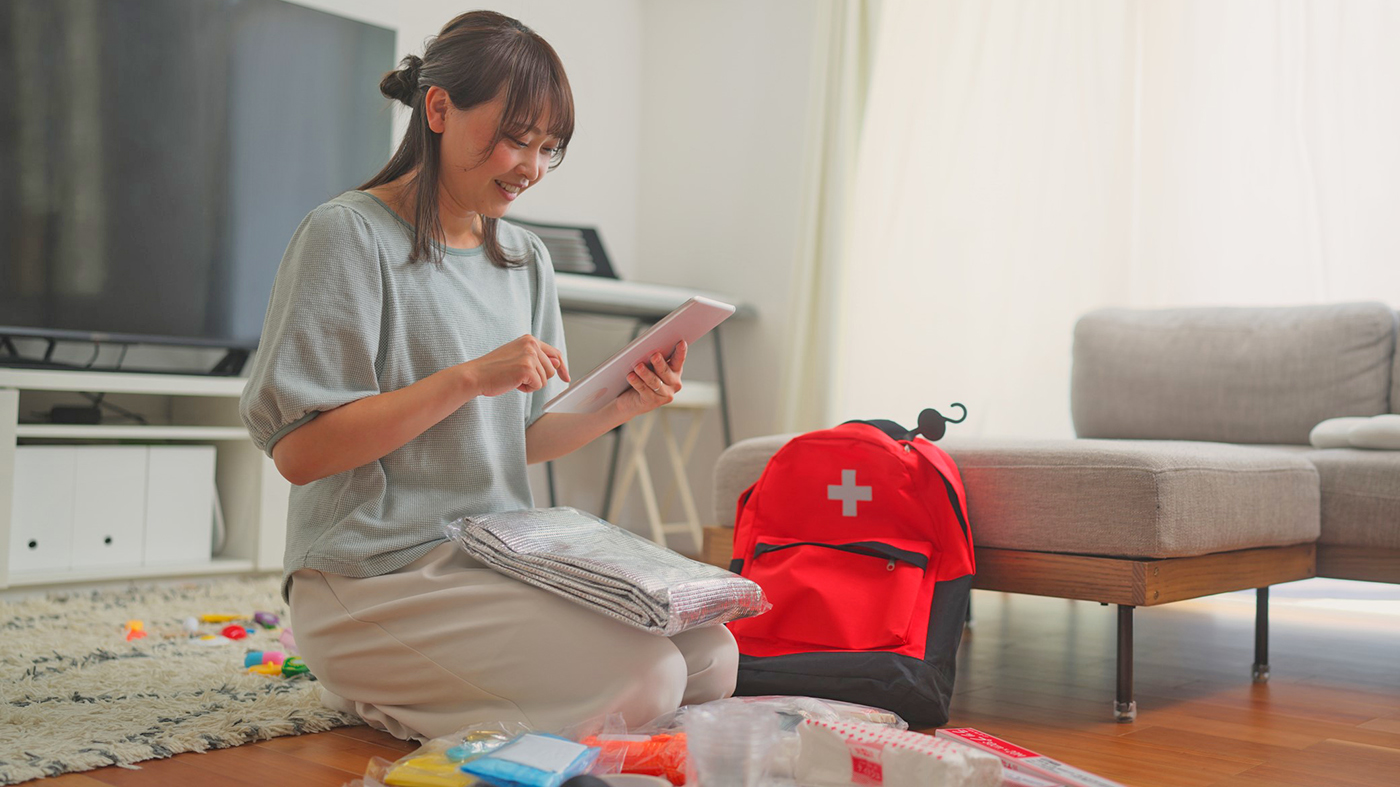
top-left (1303, 448), bottom-right (1400, 549)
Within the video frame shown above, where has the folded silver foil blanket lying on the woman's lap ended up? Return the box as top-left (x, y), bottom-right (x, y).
top-left (448, 507), bottom-right (770, 637)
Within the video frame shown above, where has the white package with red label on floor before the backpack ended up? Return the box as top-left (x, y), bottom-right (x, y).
top-left (797, 721), bottom-right (1001, 787)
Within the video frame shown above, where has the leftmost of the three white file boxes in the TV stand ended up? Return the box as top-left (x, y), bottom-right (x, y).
top-left (10, 445), bottom-right (76, 573)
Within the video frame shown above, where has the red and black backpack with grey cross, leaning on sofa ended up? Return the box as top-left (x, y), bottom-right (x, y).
top-left (728, 405), bottom-right (974, 725)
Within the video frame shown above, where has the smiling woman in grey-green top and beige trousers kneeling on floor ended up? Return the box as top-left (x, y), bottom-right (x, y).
top-left (242, 11), bottom-right (738, 738)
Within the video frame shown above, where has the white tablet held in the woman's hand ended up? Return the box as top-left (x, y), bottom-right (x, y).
top-left (545, 295), bottom-right (734, 413)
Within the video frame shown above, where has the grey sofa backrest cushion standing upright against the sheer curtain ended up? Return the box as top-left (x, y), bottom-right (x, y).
top-left (1070, 304), bottom-right (1396, 445)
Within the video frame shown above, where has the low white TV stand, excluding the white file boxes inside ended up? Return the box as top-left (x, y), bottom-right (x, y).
top-left (0, 368), bottom-right (291, 588)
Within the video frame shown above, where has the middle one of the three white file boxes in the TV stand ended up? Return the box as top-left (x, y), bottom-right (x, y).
top-left (73, 445), bottom-right (147, 569)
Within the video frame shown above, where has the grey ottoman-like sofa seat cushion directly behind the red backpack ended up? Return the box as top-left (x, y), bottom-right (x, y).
top-left (715, 436), bottom-right (1319, 557)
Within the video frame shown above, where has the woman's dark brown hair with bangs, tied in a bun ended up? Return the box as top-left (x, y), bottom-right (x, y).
top-left (360, 11), bottom-right (574, 267)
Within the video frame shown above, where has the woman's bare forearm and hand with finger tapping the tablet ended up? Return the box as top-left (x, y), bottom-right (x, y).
top-left (272, 335), bottom-right (568, 486)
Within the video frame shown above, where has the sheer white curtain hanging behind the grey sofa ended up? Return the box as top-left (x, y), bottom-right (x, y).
top-left (826, 0), bottom-right (1400, 437)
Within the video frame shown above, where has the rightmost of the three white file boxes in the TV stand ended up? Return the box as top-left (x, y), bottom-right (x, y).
top-left (144, 445), bottom-right (214, 566)
